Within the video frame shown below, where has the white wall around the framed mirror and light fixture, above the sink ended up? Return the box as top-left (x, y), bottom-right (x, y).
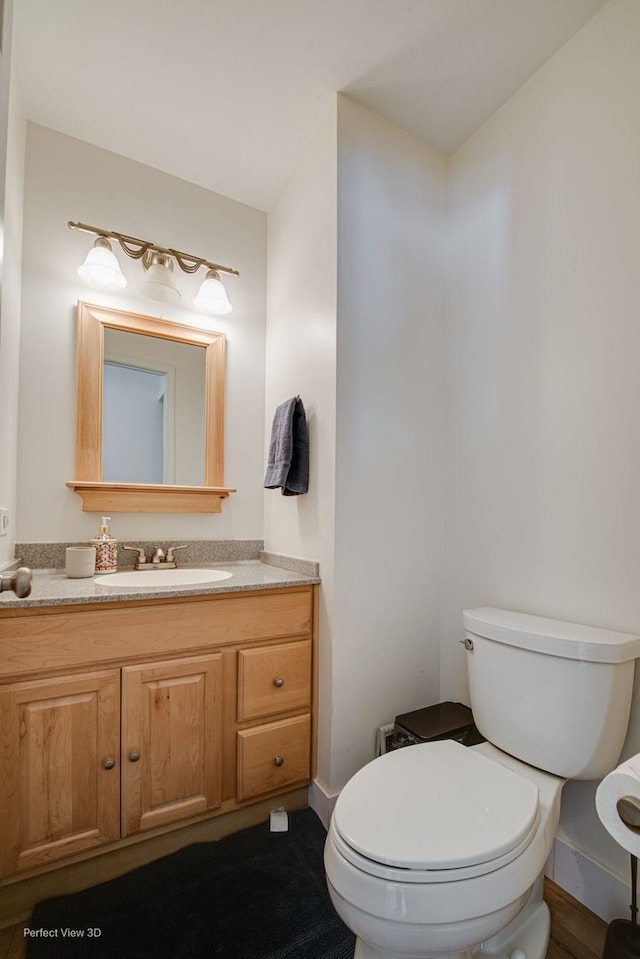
top-left (16, 124), bottom-right (266, 542)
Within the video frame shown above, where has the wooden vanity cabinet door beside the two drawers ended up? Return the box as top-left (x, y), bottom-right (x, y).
top-left (122, 653), bottom-right (223, 836)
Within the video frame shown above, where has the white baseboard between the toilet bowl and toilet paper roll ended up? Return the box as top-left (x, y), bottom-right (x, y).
top-left (545, 836), bottom-right (631, 922)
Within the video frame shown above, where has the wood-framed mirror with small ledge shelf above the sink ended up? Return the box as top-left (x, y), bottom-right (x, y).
top-left (66, 302), bottom-right (235, 513)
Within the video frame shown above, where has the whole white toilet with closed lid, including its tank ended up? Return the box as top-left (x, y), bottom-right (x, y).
top-left (324, 608), bottom-right (640, 959)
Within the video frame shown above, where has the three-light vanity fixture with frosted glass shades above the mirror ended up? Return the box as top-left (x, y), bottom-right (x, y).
top-left (68, 220), bottom-right (240, 316)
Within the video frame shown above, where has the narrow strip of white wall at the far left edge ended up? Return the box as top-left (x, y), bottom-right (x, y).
top-left (0, 0), bottom-right (25, 569)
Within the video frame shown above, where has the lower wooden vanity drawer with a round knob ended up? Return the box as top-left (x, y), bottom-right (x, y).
top-left (238, 715), bottom-right (311, 802)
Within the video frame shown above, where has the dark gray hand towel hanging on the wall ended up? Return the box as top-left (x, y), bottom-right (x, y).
top-left (264, 396), bottom-right (309, 496)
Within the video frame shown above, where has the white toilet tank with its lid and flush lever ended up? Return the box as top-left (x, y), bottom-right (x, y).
top-left (463, 607), bottom-right (640, 779)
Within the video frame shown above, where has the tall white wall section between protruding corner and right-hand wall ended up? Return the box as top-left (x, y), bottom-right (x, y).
top-left (331, 97), bottom-right (446, 788)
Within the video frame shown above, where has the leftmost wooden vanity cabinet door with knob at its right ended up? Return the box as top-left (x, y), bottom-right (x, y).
top-left (0, 670), bottom-right (120, 876)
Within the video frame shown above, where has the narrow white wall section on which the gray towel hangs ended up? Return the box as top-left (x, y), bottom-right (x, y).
top-left (264, 100), bottom-right (337, 790)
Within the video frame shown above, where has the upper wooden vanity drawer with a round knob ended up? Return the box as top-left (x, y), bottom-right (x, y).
top-left (238, 640), bottom-right (311, 723)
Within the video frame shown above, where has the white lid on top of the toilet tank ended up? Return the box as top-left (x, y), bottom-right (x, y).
top-left (462, 606), bottom-right (640, 663)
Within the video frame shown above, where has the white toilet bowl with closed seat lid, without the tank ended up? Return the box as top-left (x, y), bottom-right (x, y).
top-left (325, 740), bottom-right (564, 959)
